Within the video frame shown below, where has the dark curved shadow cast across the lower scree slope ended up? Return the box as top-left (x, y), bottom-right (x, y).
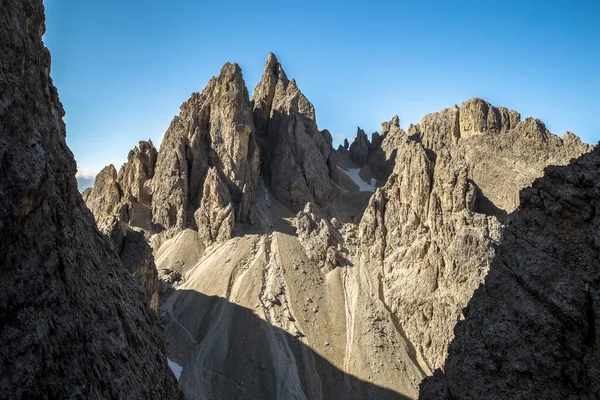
top-left (165, 290), bottom-right (408, 400)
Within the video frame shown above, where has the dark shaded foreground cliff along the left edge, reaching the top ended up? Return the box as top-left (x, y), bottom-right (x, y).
top-left (0, 0), bottom-right (180, 399)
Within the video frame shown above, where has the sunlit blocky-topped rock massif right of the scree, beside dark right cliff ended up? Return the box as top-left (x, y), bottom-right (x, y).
top-left (360, 99), bottom-right (588, 371)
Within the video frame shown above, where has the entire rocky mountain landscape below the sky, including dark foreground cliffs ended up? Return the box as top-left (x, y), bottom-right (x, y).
top-left (0, 0), bottom-right (600, 399)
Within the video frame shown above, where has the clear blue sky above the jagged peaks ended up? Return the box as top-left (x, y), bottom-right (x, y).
top-left (44, 0), bottom-right (600, 184)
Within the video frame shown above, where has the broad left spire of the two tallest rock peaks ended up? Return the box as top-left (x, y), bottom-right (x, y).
top-left (152, 64), bottom-right (259, 235)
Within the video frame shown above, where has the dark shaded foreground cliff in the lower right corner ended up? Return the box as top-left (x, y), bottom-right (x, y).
top-left (420, 149), bottom-right (600, 399)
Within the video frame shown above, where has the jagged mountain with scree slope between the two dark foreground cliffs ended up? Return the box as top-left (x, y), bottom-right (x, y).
top-left (86, 47), bottom-right (589, 399)
